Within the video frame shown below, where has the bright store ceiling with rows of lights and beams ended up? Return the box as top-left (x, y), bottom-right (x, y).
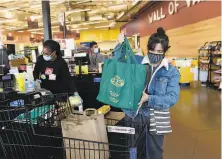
top-left (0, 0), bottom-right (147, 33)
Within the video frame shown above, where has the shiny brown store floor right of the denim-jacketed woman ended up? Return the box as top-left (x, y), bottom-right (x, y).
top-left (164, 88), bottom-right (221, 159)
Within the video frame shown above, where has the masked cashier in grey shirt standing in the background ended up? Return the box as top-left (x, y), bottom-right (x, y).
top-left (89, 41), bottom-right (104, 72)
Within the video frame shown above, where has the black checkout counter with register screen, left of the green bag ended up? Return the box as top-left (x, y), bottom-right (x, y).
top-left (73, 53), bottom-right (121, 112)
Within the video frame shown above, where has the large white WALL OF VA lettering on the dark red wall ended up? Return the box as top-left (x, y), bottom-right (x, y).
top-left (148, 0), bottom-right (205, 24)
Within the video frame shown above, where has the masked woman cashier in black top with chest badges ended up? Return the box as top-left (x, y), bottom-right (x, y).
top-left (33, 40), bottom-right (78, 95)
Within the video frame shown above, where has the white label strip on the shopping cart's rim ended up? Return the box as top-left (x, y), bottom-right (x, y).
top-left (107, 126), bottom-right (135, 134)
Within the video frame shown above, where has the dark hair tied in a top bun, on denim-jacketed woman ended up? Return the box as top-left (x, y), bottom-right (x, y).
top-left (147, 27), bottom-right (170, 52)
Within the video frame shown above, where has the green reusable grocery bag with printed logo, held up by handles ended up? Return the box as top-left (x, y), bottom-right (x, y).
top-left (97, 38), bottom-right (147, 109)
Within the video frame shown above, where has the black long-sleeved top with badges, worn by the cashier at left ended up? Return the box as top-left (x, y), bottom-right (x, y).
top-left (33, 56), bottom-right (76, 94)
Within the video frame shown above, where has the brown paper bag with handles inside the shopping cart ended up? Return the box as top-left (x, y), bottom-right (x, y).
top-left (62, 109), bottom-right (109, 159)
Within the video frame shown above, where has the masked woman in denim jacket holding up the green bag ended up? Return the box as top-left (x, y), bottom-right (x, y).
top-left (124, 28), bottom-right (180, 159)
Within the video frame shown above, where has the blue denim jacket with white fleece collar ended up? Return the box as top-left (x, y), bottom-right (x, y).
top-left (123, 56), bottom-right (180, 118)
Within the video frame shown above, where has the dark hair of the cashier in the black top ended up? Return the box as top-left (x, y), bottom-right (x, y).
top-left (43, 40), bottom-right (62, 56)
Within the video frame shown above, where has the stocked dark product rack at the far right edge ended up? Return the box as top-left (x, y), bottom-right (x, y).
top-left (199, 41), bottom-right (222, 89)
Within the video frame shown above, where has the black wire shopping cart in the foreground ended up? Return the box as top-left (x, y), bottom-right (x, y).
top-left (0, 94), bottom-right (147, 159)
